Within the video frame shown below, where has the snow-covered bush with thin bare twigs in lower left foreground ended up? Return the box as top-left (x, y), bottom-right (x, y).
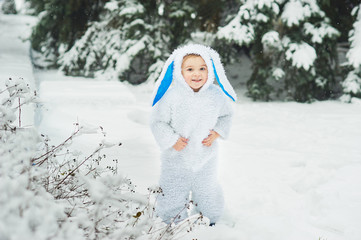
top-left (0, 78), bottom-right (205, 240)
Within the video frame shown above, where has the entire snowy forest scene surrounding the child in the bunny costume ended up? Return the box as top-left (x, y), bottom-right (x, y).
top-left (0, 0), bottom-right (361, 240)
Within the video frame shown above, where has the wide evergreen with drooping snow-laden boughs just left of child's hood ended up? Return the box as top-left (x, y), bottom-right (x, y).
top-left (59, 0), bottom-right (194, 84)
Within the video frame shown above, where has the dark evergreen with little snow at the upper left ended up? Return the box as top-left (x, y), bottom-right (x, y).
top-left (30, 0), bottom-right (107, 65)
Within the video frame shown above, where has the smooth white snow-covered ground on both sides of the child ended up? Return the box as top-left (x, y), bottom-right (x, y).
top-left (0, 12), bottom-right (361, 240)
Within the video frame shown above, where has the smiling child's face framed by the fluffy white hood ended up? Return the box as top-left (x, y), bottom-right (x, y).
top-left (182, 55), bottom-right (208, 92)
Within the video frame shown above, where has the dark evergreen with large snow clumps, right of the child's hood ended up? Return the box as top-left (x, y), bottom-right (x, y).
top-left (217, 0), bottom-right (339, 102)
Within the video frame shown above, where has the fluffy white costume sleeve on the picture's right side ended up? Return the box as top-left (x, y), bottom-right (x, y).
top-left (213, 101), bottom-right (233, 139)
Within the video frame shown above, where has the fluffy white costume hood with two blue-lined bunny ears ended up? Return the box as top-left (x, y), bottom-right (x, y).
top-left (152, 44), bottom-right (237, 106)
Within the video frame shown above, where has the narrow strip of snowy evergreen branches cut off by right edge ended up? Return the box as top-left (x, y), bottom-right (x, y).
top-left (342, 4), bottom-right (361, 102)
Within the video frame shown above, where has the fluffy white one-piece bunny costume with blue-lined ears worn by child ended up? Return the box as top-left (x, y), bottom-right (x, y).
top-left (151, 44), bottom-right (236, 223)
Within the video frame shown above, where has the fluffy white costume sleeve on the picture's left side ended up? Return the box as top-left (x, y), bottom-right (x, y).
top-left (150, 102), bottom-right (179, 151)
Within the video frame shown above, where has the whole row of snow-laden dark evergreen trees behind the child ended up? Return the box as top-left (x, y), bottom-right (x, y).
top-left (4, 0), bottom-right (361, 102)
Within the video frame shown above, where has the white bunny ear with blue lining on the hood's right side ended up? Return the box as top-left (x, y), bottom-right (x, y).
top-left (210, 49), bottom-right (237, 102)
